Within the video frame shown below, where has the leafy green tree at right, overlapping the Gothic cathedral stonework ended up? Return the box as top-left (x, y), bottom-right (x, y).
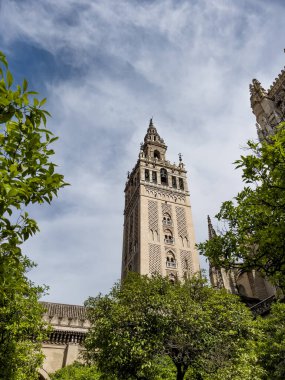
top-left (198, 122), bottom-right (285, 292)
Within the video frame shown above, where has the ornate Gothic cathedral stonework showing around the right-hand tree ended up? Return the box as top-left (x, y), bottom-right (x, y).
top-left (208, 63), bottom-right (285, 314)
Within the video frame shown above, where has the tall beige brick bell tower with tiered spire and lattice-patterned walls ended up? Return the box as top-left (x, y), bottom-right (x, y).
top-left (122, 119), bottom-right (200, 281)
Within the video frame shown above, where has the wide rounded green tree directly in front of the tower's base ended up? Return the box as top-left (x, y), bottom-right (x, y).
top-left (85, 274), bottom-right (262, 380)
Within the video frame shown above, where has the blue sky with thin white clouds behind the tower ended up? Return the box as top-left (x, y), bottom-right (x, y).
top-left (0, 0), bottom-right (285, 304)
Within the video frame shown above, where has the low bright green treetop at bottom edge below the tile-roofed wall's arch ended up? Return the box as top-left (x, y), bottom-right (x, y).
top-left (50, 362), bottom-right (100, 380)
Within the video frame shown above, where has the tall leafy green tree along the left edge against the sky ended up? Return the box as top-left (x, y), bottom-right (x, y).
top-left (0, 52), bottom-right (65, 380)
